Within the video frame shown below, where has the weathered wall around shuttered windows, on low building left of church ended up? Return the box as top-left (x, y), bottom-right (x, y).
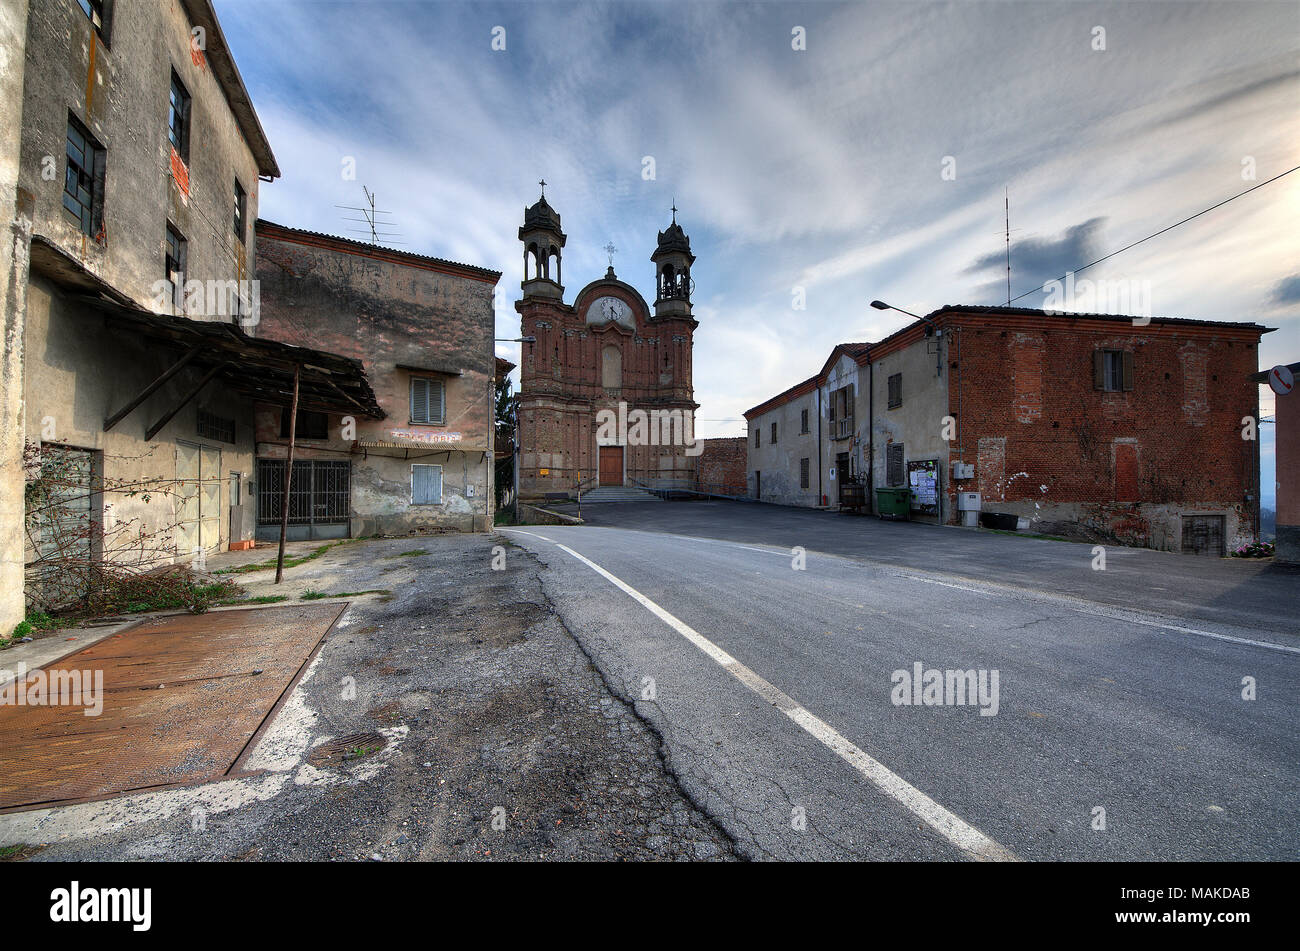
top-left (257, 222), bottom-right (495, 537)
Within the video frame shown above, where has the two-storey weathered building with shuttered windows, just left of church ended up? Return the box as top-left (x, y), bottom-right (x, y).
top-left (256, 220), bottom-right (501, 539)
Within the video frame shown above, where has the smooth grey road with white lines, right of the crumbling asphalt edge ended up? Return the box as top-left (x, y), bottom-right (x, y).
top-left (504, 503), bottom-right (1300, 860)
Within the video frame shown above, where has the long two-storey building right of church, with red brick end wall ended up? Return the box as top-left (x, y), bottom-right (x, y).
top-left (746, 307), bottom-right (1268, 553)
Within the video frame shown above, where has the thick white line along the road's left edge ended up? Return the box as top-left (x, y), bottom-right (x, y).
top-left (502, 529), bottom-right (1019, 861)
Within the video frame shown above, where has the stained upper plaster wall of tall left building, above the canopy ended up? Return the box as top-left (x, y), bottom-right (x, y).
top-left (20, 0), bottom-right (259, 320)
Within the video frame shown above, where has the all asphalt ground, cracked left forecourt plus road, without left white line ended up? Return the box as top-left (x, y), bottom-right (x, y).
top-left (0, 503), bottom-right (1300, 861)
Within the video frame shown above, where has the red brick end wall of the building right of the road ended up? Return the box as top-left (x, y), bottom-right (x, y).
top-left (948, 314), bottom-right (1258, 543)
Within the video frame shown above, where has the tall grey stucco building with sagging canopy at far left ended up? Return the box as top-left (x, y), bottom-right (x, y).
top-left (0, 0), bottom-right (380, 631)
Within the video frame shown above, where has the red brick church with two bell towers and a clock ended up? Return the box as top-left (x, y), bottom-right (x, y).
top-left (515, 192), bottom-right (698, 499)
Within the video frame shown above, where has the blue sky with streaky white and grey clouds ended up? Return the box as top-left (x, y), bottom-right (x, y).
top-left (216, 0), bottom-right (1300, 507)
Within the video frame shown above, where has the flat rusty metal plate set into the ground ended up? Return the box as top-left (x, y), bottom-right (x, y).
top-left (0, 603), bottom-right (347, 812)
